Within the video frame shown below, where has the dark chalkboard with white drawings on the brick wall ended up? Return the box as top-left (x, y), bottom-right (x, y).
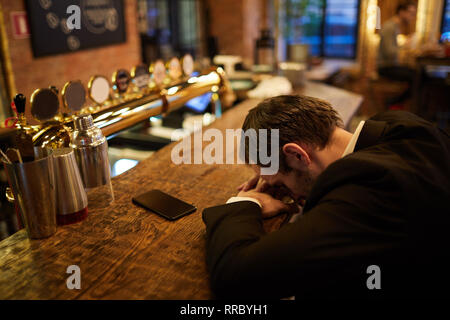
top-left (26, 0), bottom-right (126, 57)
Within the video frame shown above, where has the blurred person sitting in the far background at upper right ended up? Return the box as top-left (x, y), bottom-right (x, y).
top-left (377, 2), bottom-right (417, 104)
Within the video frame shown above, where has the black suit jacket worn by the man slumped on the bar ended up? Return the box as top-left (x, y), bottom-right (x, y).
top-left (203, 111), bottom-right (450, 299)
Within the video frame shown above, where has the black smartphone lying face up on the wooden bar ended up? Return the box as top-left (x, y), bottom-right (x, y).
top-left (133, 190), bottom-right (197, 220)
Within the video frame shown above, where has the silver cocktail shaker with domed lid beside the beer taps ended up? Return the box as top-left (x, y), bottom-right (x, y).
top-left (70, 114), bottom-right (114, 209)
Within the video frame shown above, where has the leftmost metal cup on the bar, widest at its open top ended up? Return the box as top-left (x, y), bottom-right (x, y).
top-left (3, 156), bottom-right (56, 239)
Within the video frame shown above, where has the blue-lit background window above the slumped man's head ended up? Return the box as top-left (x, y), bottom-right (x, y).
top-left (285, 0), bottom-right (360, 58)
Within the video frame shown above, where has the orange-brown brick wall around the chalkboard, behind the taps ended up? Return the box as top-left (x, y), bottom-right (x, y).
top-left (0, 0), bottom-right (141, 122)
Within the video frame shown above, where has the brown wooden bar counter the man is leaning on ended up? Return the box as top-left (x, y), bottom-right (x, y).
top-left (0, 83), bottom-right (362, 299)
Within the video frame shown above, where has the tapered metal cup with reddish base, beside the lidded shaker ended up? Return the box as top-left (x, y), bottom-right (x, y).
top-left (52, 148), bottom-right (88, 225)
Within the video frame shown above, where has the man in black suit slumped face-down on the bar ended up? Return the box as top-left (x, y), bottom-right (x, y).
top-left (203, 96), bottom-right (450, 299)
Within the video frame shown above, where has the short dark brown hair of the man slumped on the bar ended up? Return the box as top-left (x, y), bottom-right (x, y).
top-left (241, 95), bottom-right (343, 172)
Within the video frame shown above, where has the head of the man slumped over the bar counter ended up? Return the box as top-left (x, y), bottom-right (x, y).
top-left (242, 95), bottom-right (342, 198)
